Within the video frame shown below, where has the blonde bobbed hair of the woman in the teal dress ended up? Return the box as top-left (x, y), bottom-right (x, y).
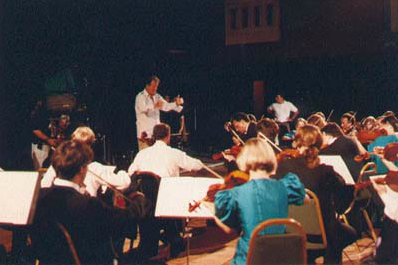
top-left (236, 138), bottom-right (277, 174)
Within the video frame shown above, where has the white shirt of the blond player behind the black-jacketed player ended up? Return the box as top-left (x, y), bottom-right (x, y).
top-left (41, 162), bottom-right (131, 197)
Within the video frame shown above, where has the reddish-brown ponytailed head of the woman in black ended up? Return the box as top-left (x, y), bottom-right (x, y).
top-left (294, 125), bottom-right (323, 168)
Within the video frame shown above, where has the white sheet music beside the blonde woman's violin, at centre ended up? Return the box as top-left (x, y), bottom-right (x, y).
top-left (155, 177), bottom-right (223, 219)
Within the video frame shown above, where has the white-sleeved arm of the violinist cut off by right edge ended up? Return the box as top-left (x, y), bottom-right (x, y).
top-left (369, 175), bottom-right (398, 222)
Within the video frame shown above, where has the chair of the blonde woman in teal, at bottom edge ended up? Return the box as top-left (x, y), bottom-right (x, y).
top-left (246, 218), bottom-right (307, 265)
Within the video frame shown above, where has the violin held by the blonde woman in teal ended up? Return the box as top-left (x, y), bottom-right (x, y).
top-left (188, 170), bottom-right (250, 212)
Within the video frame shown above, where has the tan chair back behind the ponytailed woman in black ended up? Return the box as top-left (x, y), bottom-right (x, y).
top-left (287, 189), bottom-right (327, 249)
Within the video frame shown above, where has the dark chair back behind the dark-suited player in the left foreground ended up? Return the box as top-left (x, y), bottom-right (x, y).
top-left (30, 221), bottom-right (80, 265)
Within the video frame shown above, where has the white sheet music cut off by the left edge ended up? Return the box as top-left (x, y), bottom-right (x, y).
top-left (0, 171), bottom-right (39, 225)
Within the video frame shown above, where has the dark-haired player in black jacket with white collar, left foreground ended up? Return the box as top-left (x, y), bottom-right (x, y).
top-left (31, 141), bottom-right (147, 264)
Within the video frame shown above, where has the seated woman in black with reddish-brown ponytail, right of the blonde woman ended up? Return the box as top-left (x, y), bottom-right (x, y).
top-left (275, 125), bottom-right (356, 264)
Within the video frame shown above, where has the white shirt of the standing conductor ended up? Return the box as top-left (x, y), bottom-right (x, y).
top-left (135, 89), bottom-right (182, 138)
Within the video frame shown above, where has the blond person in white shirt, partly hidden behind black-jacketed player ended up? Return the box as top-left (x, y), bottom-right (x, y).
top-left (41, 127), bottom-right (131, 197)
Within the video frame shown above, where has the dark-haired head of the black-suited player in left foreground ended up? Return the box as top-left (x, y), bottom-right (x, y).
top-left (51, 141), bottom-right (93, 180)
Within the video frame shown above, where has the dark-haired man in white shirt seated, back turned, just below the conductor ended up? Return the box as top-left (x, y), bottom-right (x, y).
top-left (128, 123), bottom-right (203, 260)
